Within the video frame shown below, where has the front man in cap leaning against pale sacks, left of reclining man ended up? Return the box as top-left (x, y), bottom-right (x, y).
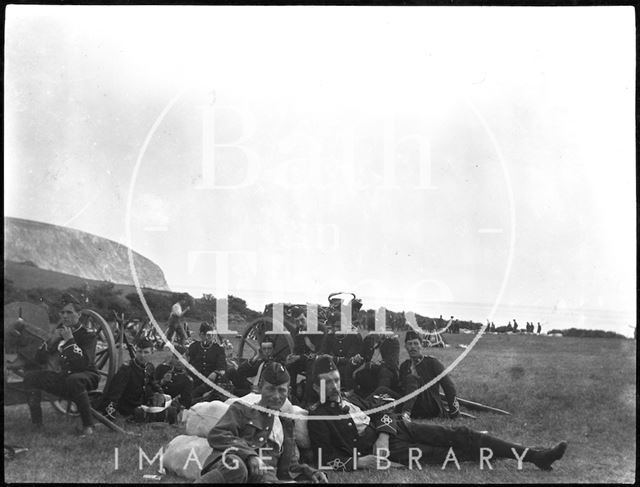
top-left (196, 362), bottom-right (327, 484)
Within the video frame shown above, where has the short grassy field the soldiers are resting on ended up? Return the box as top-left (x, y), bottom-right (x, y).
top-left (4, 335), bottom-right (636, 483)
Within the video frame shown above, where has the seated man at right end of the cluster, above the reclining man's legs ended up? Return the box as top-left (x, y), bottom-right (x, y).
top-left (400, 330), bottom-right (460, 424)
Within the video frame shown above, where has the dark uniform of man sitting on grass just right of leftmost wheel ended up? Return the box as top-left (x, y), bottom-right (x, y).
top-left (103, 360), bottom-right (163, 416)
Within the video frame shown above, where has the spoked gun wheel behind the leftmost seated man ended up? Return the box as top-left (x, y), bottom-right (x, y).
top-left (51, 309), bottom-right (120, 416)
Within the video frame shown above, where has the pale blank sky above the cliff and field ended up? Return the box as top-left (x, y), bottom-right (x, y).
top-left (4, 5), bottom-right (636, 335)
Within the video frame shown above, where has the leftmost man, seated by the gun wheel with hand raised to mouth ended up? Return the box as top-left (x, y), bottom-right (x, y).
top-left (24, 294), bottom-right (100, 435)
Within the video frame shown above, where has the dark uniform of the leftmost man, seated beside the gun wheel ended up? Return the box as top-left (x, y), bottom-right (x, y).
top-left (24, 325), bottom-right (100, 426)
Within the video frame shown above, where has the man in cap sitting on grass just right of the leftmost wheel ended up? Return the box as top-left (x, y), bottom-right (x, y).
top-left (101, 338), bottom-right (177, 424)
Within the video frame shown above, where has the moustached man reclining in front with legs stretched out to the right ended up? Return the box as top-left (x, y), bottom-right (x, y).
top-left (308, 355), bottom-right (567, 471)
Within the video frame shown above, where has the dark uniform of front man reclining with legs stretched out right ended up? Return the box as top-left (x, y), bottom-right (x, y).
top-left (308, 397), bottom-right (566, 471)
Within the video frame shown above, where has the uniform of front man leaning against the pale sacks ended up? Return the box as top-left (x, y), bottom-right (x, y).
top-left (199, 401), bottom-right (316, 483)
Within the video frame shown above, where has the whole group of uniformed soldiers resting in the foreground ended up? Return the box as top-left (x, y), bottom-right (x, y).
top-left (24, 295), bottom-right (566, 483)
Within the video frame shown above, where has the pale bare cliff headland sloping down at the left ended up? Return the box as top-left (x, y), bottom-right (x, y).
top-left (4, 217), bottom-right (169, 291)
